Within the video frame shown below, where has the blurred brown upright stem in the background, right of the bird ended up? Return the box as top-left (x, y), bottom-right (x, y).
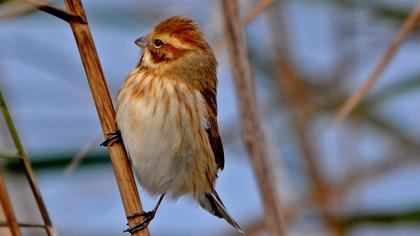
top-left (270, 1), bottom-right (345, 236)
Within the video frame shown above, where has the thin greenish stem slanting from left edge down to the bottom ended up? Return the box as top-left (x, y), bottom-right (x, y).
top-left (0, 90), bottom-right (55, 236)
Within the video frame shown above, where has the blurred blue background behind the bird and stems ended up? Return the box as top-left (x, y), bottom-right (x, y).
top-left (0, 0), bottom-right (420, 236)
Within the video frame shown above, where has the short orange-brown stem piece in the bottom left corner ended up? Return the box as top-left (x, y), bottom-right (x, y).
top-left (0, 172), bottom-right (22, 236)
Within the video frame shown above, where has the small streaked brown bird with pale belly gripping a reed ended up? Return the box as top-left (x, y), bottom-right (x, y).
top-left (112, 16), bottom-right (242, 232)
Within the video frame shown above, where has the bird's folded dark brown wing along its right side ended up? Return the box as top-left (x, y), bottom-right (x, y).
top-left (200, 89), bottom-right (225, 170)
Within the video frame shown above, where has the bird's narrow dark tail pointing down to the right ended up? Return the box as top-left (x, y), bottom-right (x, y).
top-left (198, 191), bottom-right (243, 233)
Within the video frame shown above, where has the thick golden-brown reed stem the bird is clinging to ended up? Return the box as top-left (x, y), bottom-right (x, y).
top-left (60, 0), bottom-right (149, 236)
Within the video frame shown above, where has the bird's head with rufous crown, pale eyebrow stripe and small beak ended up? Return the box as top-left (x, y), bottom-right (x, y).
top-left (135, 16), bottom-right (214, 72)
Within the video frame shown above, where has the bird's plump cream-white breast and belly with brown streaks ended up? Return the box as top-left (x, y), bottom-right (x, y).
top-left (116, 74), bottom-right (217, 198)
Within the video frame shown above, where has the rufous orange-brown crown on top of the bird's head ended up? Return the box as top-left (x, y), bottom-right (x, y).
top-left (153, 16), bottom-right (209, 49)
